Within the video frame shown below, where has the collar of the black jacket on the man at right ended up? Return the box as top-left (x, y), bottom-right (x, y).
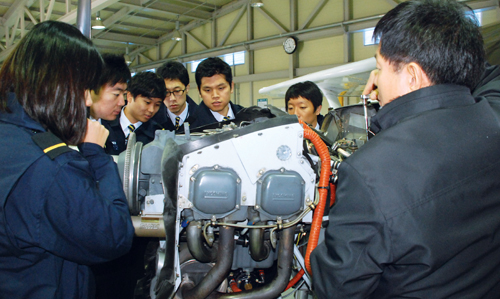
top-left (370, 84), bottom-right (475, 134)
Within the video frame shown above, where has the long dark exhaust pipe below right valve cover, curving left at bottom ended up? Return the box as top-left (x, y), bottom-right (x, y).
top-left (212, 226), bottom-right (295, 299)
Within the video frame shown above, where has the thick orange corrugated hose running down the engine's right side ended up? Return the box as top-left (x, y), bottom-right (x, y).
top-left (299, 120), bottom-right (332, 275)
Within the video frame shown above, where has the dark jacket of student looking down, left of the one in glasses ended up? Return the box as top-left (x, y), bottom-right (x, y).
top-left (101, 113), bottom-right (163, 155)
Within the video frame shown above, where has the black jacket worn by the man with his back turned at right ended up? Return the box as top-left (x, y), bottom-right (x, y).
top-left (311, 85), bottom-right (500, 299)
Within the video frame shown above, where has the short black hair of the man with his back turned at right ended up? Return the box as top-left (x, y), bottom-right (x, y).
top-left (373, 0), bottom-right (485, 89)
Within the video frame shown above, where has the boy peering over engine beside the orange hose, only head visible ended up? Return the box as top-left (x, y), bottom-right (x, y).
top-left (285, 81), bottom-right (324, 130)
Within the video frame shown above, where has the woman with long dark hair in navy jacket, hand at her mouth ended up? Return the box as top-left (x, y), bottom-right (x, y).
top-left (0, 21), bottom-right (134, 299)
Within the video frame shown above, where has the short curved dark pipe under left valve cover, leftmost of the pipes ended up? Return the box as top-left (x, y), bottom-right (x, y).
top-left (187, 221), bottom-right (217, 263)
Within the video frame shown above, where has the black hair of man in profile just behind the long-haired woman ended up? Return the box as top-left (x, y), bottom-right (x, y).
top-left (94, 53), bottom-right (131, 94)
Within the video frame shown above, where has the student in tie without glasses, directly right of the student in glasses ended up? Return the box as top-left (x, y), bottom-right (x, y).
top-left (191, 57), bottom-right (243, 128)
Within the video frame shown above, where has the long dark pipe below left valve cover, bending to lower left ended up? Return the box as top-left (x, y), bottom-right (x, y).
top-left (178, 226), bottom-right (235, 299)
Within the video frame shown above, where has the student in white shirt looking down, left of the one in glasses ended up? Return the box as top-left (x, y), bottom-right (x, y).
top-left (102, 72), bottom-right (166, 155)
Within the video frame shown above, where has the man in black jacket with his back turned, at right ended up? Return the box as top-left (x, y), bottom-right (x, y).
top-left (311, 0), bottom-right (500, 298)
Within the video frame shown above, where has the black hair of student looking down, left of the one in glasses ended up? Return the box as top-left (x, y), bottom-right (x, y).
top-left (127, 72), bottom-right (167, 100)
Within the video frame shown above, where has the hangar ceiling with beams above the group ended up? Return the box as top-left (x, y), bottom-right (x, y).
top-left (0, 0), bottom-right (498, 68)
